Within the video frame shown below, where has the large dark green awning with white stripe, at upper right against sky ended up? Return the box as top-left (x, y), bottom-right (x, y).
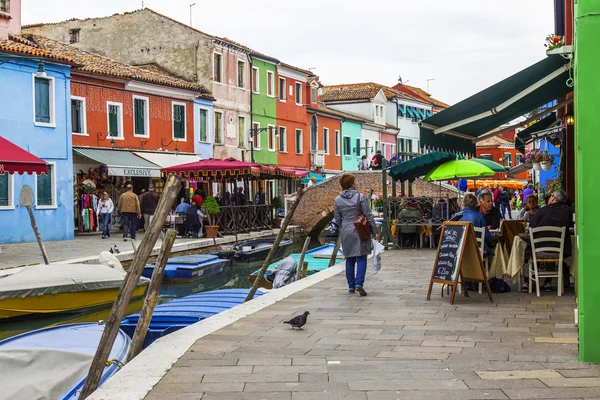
top-left (420, 55), bottom-right (573, 154)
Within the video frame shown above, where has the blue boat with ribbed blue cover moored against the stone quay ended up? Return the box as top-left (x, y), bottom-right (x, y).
top-left (121, 289), bottom-right (263, 348)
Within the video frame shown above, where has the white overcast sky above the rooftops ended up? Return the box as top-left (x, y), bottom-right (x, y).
top-left (22, 0), bottom-right (554, 104)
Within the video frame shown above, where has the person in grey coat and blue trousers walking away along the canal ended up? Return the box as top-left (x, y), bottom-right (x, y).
top-left (333, 173), bottom-right (379, 296)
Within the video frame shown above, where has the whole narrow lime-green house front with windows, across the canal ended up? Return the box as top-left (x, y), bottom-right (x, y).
top-left (250, 53), bottom-right (278, 165)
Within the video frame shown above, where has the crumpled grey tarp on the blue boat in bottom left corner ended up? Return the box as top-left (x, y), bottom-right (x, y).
top-left (0, 348), bottom-right (94, 400)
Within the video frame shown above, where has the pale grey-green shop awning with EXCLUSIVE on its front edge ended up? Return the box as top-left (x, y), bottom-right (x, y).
top-left (73, 147), bottom-right (160, 178)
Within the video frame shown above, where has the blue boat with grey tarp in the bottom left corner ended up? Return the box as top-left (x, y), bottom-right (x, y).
top-left (0, 323), bottom-right (131, 400)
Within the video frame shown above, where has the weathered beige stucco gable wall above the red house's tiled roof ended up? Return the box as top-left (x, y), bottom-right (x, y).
top-left (27, 9), bottom-right (212, 88)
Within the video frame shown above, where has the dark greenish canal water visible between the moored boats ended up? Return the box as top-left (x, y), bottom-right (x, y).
top-left (0, 236), bottom-right (321, 340)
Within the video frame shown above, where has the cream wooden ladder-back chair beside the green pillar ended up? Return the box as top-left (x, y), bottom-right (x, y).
top-left (529, 226), bottom-right (566, 297)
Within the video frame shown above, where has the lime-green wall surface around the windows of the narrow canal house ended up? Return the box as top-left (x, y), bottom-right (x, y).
top-left (252, 59), bottom-right (278, 165)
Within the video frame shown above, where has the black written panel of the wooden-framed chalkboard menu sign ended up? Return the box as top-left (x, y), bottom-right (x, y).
top-left (433, 225), bottom-right (466, 281)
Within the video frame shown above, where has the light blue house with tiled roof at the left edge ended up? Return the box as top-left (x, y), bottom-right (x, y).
top-left (0, 42), bottom-right (74, 244)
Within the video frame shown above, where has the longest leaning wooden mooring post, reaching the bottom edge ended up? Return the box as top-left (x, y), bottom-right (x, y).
top-left (79, 174), bottom-right (181, 400)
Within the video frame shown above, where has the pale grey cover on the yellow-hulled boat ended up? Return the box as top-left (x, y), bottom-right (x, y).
top-left (0, 264), bottom-right (149, 300)
